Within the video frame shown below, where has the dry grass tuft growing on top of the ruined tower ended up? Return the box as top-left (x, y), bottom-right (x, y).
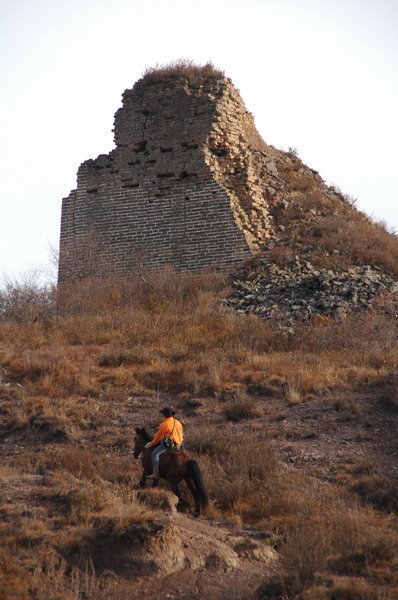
top-left (141, 58), bottom-right (224, 84)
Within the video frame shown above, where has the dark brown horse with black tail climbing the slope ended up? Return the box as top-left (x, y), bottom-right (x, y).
top-left (133, 427), bottom-right (209, 517)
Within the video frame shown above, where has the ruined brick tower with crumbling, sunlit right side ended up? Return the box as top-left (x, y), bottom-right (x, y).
top-left (59, 69), bottom-right (314, 283)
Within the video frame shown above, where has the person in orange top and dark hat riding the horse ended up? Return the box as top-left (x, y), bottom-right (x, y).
top-left (145, 406), bottom-right (183, 479)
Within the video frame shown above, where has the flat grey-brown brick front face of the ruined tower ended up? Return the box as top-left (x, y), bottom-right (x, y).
top-left (59, 78), bottom-right (256, 283)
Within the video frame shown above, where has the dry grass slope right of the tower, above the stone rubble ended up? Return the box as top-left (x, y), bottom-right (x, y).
top-left (273, 153), bottom-right (398, 276)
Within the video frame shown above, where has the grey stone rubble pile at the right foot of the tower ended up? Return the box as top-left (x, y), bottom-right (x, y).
top-left (223, 256), bottom-right (398, 327)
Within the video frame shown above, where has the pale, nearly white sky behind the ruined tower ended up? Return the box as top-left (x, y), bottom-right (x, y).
top-left (0, 0), bottom-right (398, 283)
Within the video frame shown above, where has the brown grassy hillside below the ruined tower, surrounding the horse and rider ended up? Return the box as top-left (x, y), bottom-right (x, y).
top-left (0, 270), bottom-right (398, 600)
